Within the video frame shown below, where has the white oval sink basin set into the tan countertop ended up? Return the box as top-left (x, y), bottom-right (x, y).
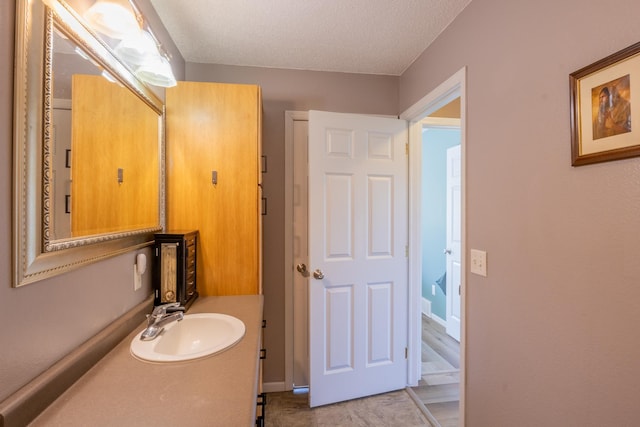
top-left (131, 313), bottom-right (245, 362)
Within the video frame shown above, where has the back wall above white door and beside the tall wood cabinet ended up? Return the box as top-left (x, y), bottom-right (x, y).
top-left (186, 63), bottom-right (398, 383)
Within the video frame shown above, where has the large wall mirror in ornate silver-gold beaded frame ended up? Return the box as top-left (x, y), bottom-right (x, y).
top-left (13, 0), bottom-right (165, 287)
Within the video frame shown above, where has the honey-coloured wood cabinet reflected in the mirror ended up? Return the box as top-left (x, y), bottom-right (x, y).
top-left (71, 75), bottom-right (160, 236)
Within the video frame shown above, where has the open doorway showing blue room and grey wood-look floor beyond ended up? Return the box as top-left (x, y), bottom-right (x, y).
top-left (411, 112), bottom-right (462, 425)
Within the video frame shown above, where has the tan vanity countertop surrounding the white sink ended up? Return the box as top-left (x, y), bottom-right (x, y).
top-left (30, 295), bottom-right (263, 427)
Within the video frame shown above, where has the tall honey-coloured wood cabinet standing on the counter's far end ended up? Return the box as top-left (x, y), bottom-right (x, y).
top-left (166, 82), bottom-right (262, 296)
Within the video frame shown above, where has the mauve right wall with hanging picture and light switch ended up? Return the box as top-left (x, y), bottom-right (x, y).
top-left (399, 0), bottom-right (640, 427)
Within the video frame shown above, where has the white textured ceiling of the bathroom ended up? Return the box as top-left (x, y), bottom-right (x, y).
top-left (151, 0), bottom-right (471, 76)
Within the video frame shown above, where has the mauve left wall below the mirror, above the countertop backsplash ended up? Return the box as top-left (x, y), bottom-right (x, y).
top-left (0, 1), bottom-right (184, 401)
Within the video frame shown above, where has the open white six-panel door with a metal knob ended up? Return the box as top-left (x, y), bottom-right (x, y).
top-left (309, 111), bottom-right (408, 407)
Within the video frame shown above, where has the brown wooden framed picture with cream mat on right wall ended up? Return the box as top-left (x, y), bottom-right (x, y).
top-left (569, 42), bottom-right (640, 166)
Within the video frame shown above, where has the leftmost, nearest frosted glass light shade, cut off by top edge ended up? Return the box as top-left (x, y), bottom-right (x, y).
top-left (84, 0), bottom-right (140, 39)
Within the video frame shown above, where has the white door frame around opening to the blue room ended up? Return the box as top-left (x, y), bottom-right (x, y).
top-left (400, 67), bottom-right (467, 425)
